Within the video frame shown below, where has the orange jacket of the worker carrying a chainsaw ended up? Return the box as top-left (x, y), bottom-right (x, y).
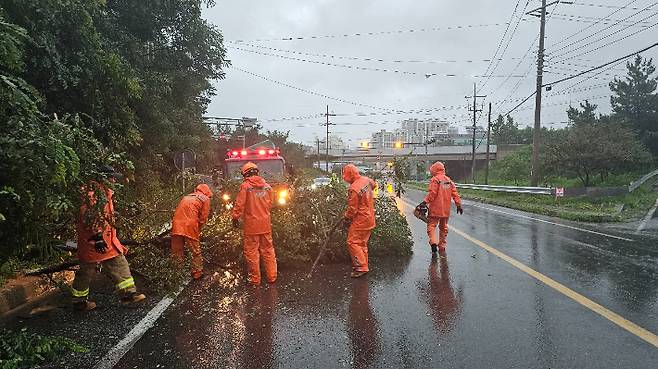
top-left (425, 161), bottom-right (462, 218)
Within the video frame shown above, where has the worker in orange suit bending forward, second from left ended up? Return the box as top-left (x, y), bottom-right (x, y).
top-left (171, 183), bottom-right (212, 280)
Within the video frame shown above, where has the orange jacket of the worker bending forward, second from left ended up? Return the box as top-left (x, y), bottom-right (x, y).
top-left (171, 184), bottom-right (212, 241)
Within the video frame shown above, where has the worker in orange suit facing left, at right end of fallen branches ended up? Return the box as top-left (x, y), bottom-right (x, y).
top-left (343, 164), bottom-right (376, 278)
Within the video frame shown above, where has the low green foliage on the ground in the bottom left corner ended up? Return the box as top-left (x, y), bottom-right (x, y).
top-left (0, 328), bottom-right (89, 369)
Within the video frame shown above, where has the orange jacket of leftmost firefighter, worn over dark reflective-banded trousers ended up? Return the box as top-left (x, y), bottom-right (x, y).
top-left (76, 183), bottom-right (128, 263)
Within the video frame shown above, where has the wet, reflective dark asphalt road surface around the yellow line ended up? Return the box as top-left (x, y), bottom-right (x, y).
top-left (116, 191), bottom-right (658, 369)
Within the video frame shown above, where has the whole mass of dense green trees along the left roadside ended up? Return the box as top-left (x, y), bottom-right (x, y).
top-left (0, 0), bottom-right (228, 270)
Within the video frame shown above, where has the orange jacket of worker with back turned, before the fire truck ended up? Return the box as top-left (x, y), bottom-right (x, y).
top-left (232, 176), bottom-right (274, 235)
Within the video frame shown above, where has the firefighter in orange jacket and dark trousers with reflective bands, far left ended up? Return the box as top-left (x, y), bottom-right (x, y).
top-left (71, 165), bottom-right (146, 311)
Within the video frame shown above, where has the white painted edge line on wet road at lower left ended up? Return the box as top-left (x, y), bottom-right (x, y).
top-left (93, 281), bottom-right (189, 369)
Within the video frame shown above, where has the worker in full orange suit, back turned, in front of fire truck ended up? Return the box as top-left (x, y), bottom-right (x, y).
top-left (232, 162), bottom-right (277, 286)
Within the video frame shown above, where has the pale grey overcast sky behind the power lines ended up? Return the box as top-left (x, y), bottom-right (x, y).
top-left (204, 0), bottom-right (658, 145)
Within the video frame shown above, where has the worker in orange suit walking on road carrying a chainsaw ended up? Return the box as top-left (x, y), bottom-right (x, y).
top-left (416, 161), bottom-right (464, 257)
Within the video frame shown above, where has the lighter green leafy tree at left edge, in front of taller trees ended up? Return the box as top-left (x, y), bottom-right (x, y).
top-left (0, 16), bottom-right (110, 261)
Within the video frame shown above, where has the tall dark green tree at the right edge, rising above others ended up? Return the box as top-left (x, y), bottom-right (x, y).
top-left (610, 55), bottom-right (658, 158)
